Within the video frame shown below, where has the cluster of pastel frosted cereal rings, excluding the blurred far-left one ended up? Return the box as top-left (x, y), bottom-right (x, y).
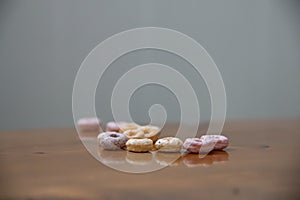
top-left (98, 122), bottom-right (229, 153)
